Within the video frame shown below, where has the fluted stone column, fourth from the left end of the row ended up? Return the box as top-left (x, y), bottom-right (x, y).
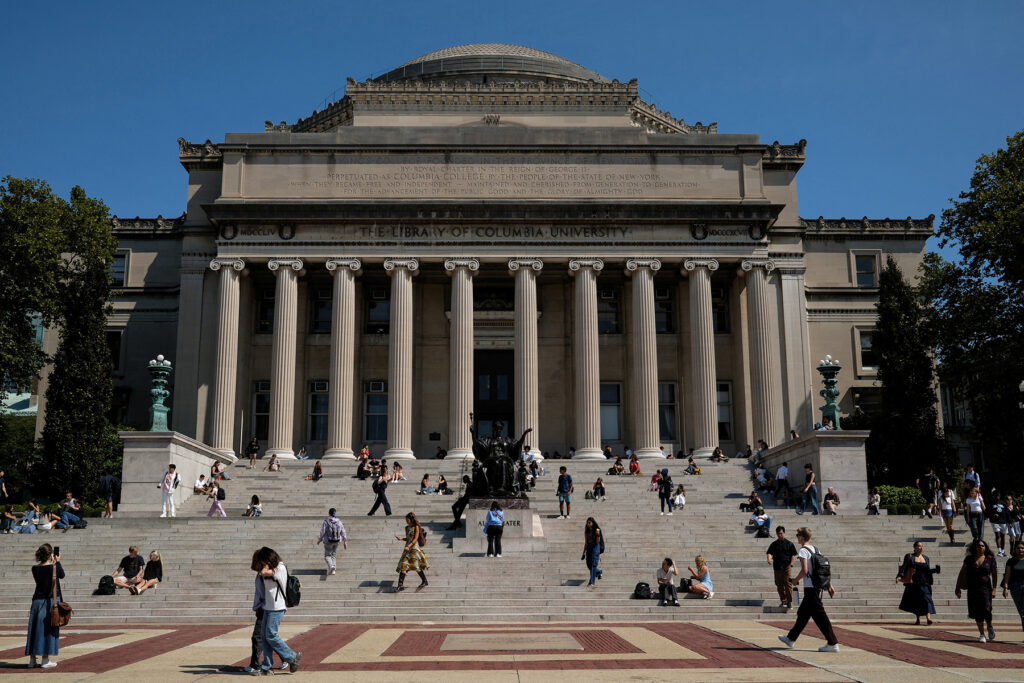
top-left (384, 258), bottom-right (420, 460)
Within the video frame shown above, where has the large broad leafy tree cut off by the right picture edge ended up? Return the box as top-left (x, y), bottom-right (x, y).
top-left (922, 131), bottom-right (1024, 487)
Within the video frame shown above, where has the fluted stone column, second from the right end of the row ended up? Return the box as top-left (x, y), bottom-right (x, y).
top-left (683, 258), bottom-right (718, 456)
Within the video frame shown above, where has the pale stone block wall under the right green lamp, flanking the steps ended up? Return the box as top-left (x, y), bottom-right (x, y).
top-left (761, 431), bottom-right (870, 511)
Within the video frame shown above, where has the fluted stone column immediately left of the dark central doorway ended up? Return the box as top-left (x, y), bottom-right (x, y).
top-left (444, 258), bottom-right (480, 460)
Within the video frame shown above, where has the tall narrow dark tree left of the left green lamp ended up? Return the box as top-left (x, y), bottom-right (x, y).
top-left (42, 186), bottom-right (117, 497)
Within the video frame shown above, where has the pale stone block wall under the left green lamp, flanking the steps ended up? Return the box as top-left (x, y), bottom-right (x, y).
top-left (118, 432), bottom-right (238, 515)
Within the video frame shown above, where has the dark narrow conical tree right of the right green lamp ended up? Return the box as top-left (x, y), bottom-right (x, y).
top-left (866, 256), bottom-right (945, 484)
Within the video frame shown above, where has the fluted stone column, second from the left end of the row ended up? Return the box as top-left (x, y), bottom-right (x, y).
top-left (266, 258), bottom-right (302, 460)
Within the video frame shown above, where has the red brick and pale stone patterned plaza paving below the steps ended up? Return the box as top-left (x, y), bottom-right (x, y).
top-left (0, 617), bottom-right (1024, 683)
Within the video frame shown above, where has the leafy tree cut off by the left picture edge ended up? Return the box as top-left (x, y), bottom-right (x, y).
top-left (0, 176), bottom-right (66, 400)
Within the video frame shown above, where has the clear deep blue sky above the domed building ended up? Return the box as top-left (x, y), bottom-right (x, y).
top-left (0, 0), bottom-right (1024, 258)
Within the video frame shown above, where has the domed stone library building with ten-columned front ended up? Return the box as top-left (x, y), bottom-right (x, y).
top-left (37, 45), bottom-right (932, 458)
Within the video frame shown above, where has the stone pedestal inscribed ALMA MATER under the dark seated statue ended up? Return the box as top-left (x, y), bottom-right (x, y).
top-left (452, 498), bottom-right (548, 555)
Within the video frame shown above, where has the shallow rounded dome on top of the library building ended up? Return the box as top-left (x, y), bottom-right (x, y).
top-left (374, 43), bottom-right (608, 83)
